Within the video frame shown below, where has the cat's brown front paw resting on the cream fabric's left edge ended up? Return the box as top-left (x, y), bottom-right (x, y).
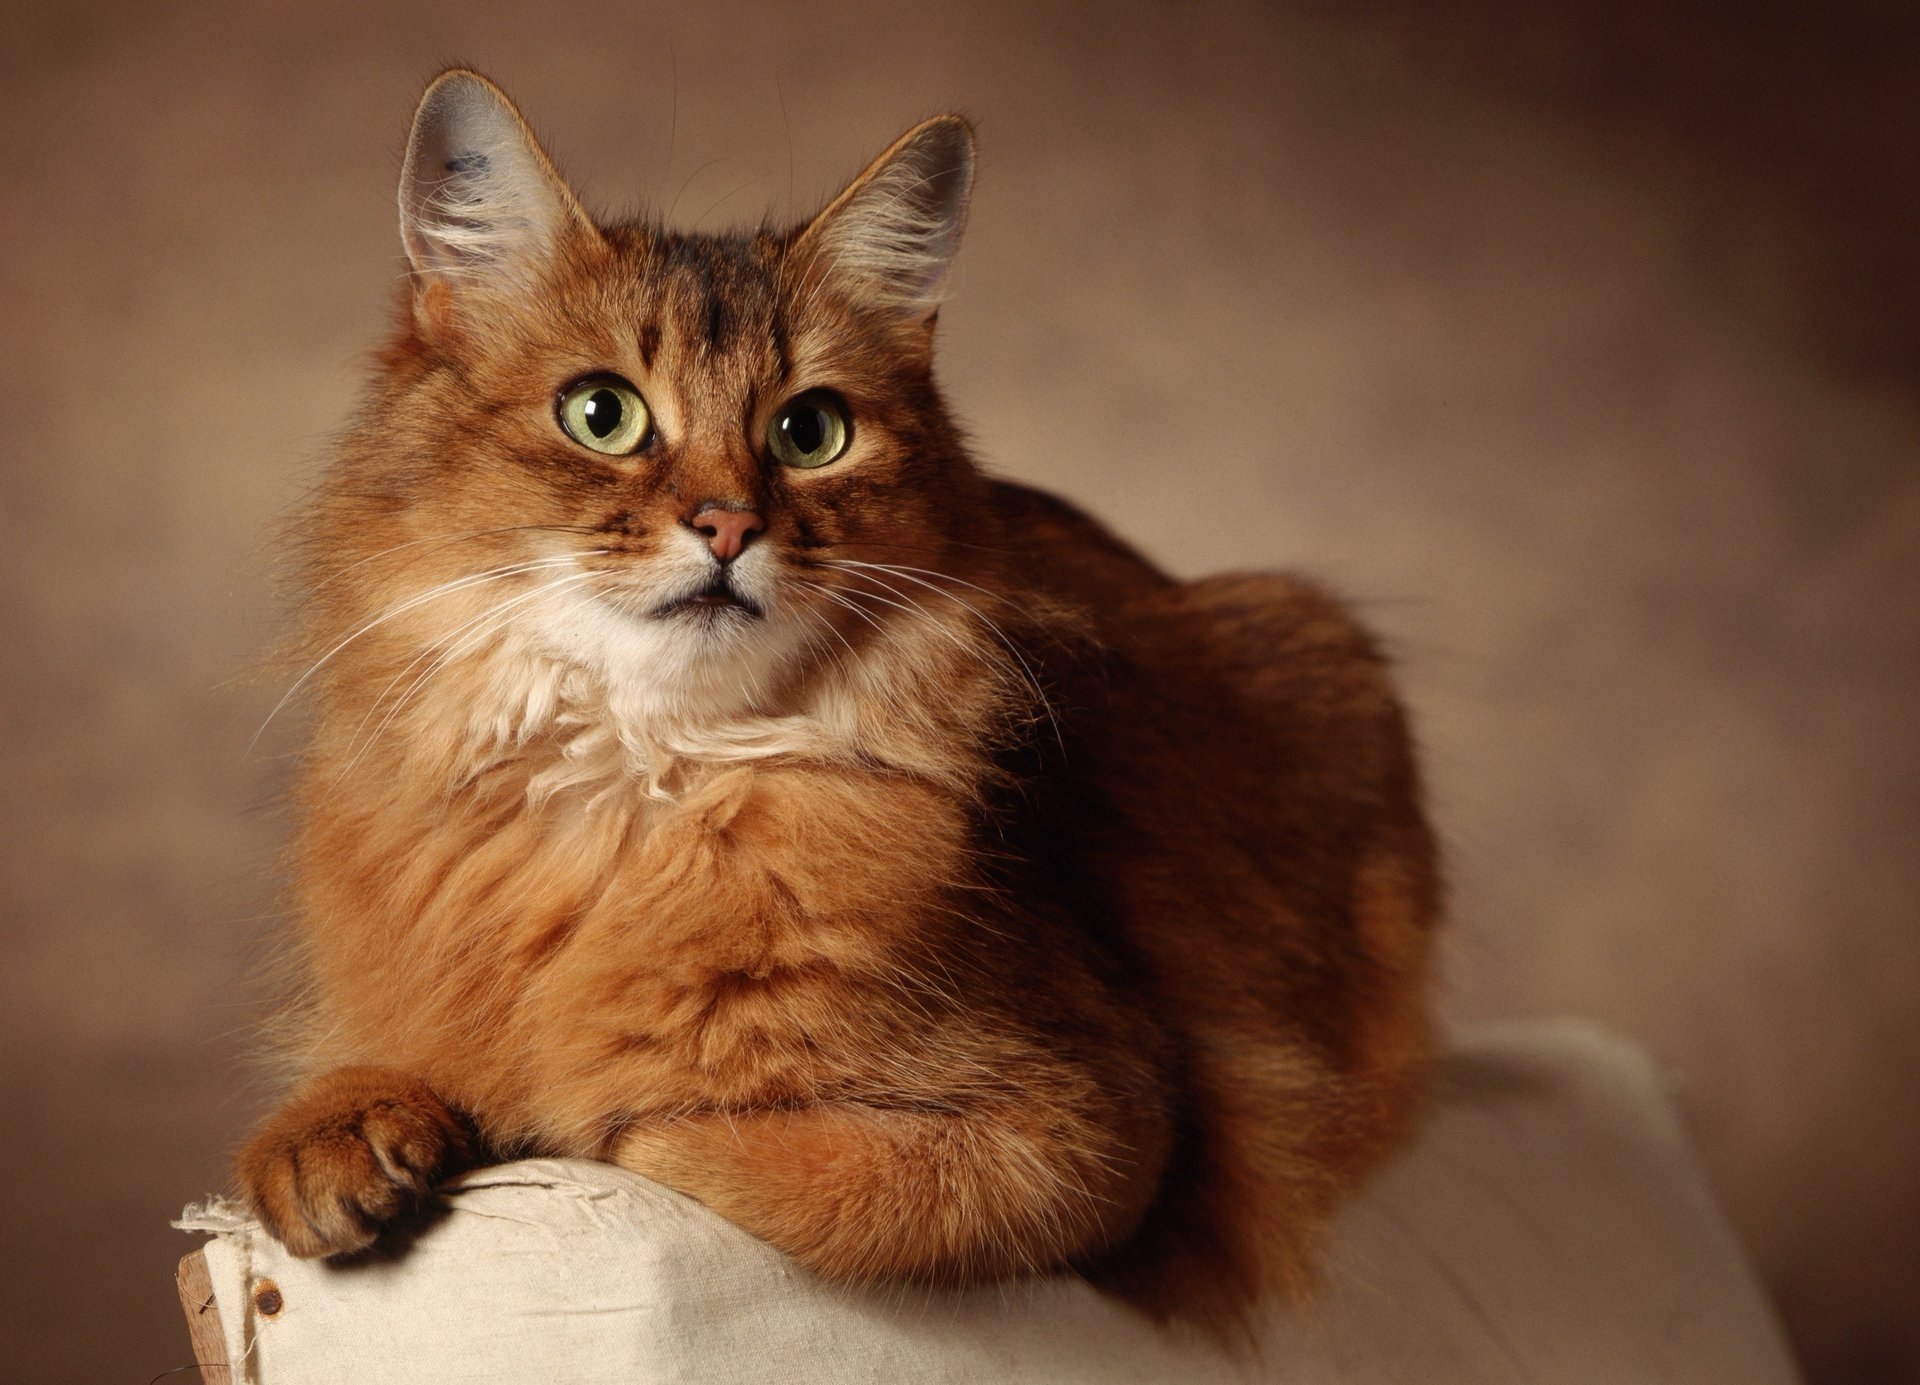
top-left (238, 1068), bottom-right (474, 1256)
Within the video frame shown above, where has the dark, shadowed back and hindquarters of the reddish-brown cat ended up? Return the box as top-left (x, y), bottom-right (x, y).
top-left (1000, 486), bottom-right (1440, 1320)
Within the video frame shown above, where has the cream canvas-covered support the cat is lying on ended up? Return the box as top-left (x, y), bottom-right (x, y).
top-left (180, 1024), bottom-right (1797, 1385)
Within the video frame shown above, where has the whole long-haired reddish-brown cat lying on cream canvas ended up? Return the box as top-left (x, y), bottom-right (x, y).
top-left (238, 69), bottom-right (1440, 1333)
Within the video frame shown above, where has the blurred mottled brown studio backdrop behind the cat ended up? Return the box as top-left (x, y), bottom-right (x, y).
top-left (0, 0), bottom-right (1920, 1381)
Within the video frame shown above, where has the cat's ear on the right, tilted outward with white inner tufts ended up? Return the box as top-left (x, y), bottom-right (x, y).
top-left (795, 115), bottom-right (973, 323)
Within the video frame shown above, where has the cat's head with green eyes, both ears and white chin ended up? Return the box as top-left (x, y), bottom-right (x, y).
top-left (311, 71), bottom-right (1036, 787)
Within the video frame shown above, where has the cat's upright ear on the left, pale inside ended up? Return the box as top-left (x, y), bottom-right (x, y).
top-left (399, 67), bottom-right (599, 290)
